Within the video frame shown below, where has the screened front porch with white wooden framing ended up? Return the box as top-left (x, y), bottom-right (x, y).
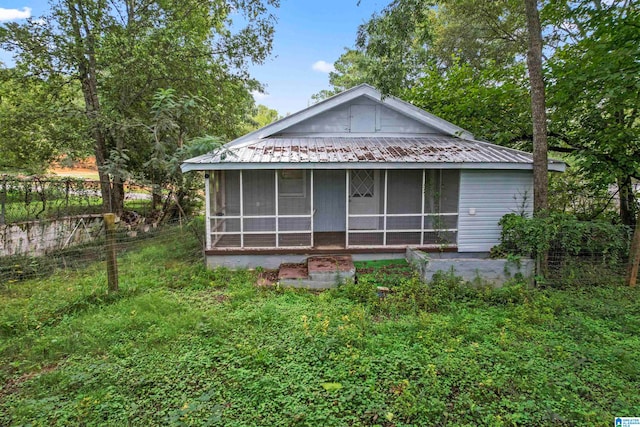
top-left (205, 169), bottom-right (460, 251)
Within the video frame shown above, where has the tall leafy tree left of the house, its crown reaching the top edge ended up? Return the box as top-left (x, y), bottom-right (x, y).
top-left (0, 0), bottom-right (278, 213)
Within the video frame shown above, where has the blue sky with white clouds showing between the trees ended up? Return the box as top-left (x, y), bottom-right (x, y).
top-left (0, 0), bottom-right (389, 115)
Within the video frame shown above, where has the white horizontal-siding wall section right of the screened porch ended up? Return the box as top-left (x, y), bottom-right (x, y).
top-left (458, 170), bottom-right (533, 252)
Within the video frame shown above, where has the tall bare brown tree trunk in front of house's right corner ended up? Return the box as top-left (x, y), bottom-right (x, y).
top-left (524, 0), bottom-right (549, 214)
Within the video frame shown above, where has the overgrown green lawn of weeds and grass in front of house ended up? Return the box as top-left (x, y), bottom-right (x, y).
top-left (0, 232), bottom-right (640, 426)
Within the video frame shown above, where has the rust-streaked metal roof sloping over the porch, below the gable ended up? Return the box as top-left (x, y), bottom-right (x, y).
top-left (183, 135), bottom-right (565, 171)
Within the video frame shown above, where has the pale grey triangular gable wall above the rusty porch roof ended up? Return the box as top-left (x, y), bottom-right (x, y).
top-left (277, 96), bottom-right (444, 136)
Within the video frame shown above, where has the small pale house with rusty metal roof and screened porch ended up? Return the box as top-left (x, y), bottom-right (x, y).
top-left (182, 84), bottom-right (565, 267)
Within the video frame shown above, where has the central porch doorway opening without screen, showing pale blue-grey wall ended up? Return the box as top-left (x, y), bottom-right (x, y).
top-left (313, 169), bottom-right (346, 232)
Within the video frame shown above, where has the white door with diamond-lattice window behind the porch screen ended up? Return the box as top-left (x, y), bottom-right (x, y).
top-left (349, 169), bottom-right (380, 230)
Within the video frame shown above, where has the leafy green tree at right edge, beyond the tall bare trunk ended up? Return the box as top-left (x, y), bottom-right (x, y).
top-left (549, 1), bottom-right (640, 226)
